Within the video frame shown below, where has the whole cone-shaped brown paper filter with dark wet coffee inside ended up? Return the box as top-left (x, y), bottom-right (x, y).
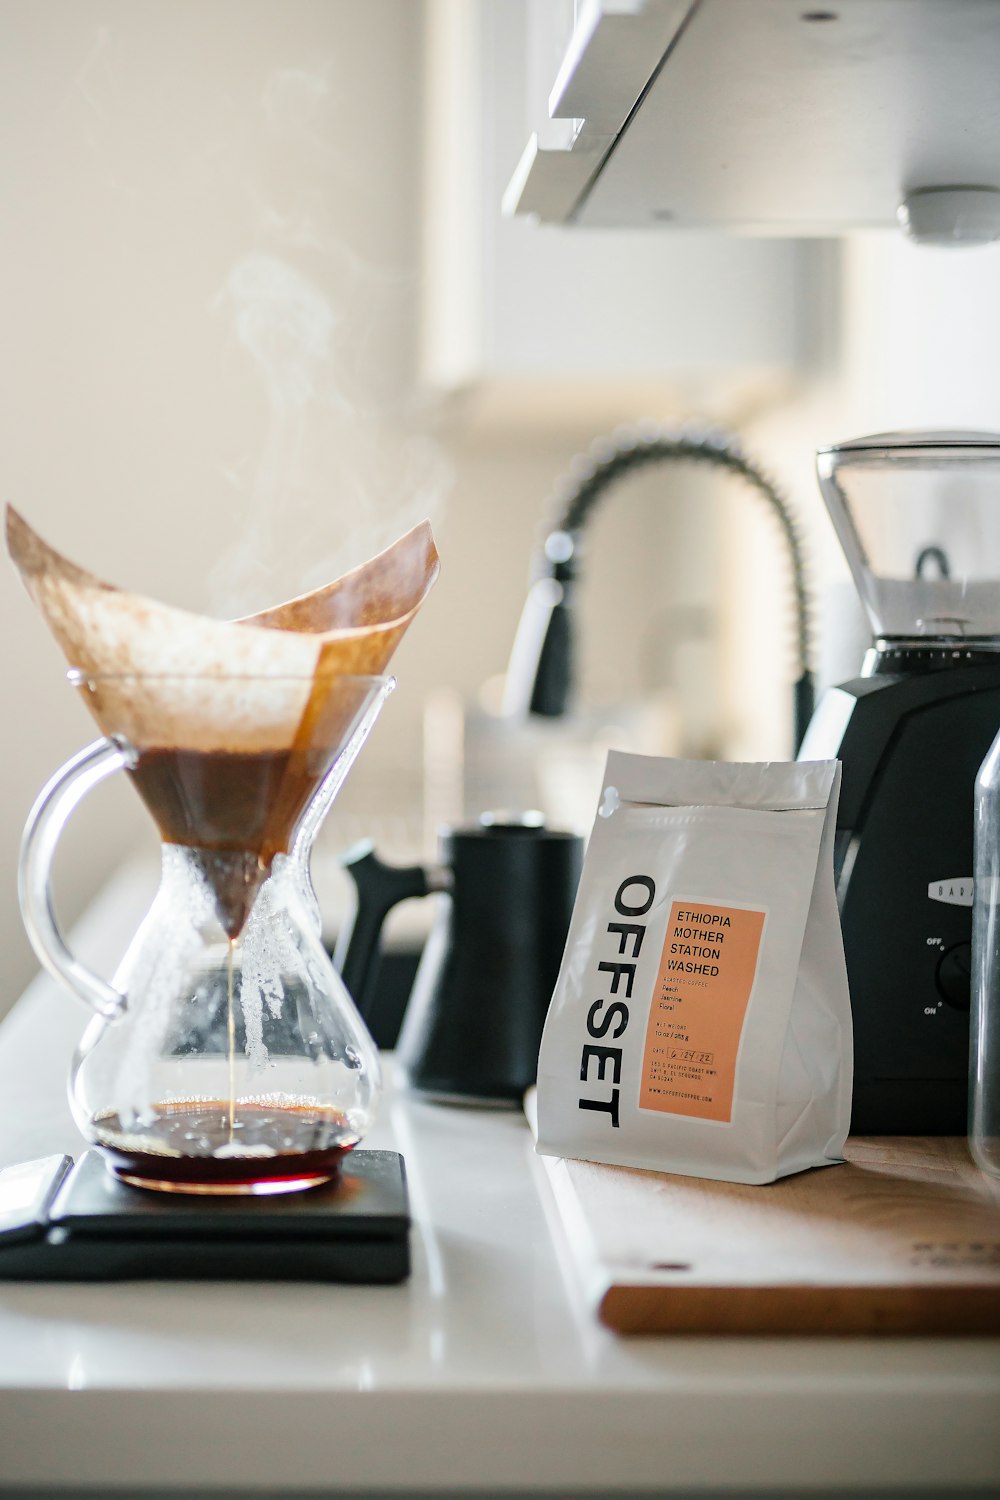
top-left (7, 507), bottom-right (438, 936)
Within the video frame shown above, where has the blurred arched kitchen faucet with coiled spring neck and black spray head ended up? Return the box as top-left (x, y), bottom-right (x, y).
top-left (504, 428), bottom-right (814, 747)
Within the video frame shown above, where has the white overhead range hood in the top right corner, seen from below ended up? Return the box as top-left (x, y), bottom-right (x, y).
top-left (504, 0), bottom-right (1000, 243)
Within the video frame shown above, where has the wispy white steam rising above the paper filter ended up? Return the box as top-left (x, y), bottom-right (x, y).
top-left (210, 68), bottom-right (447, 617)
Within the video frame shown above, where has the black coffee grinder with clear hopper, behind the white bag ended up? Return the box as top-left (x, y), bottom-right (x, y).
top-left (799, 432), bottom-right (1000, 1134)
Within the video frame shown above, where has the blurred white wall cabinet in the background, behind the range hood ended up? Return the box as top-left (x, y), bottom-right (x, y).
top-left (421, 0), bottom-right (831, 428)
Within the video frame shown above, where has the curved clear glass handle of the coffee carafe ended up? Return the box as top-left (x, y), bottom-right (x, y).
top-left (18, 740), bottom-right (129, 1020)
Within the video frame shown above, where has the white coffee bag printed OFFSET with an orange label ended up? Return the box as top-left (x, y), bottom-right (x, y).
top-left (537, 752), bottom-right (853, 1182)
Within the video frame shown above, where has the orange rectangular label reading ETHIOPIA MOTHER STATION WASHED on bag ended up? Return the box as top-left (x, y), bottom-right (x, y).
top-left (639, 902), bottom-right (765, 1121)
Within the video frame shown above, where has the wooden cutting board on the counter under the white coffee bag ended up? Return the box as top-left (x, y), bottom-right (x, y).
top-left (538, 1137), bottom-right (1000, 1335)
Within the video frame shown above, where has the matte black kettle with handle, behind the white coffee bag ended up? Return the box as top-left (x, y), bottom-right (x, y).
top-left (334, 815), bottom-right (583, 1104)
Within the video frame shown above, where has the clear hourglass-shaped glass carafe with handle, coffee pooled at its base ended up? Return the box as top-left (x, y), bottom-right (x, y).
top-left (19, 674), bottom-right (394, 1194)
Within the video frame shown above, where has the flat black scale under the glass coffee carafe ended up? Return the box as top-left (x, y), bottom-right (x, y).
top-left (0, 1151), bottom-right (409, 1284)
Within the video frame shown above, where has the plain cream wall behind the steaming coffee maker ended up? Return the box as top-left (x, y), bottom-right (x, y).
top-left (0, 0), bottom-right (719, 1014)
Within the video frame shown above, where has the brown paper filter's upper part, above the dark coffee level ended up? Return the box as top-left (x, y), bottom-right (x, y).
top-left (6, 506), bottom-right (438, 752)
